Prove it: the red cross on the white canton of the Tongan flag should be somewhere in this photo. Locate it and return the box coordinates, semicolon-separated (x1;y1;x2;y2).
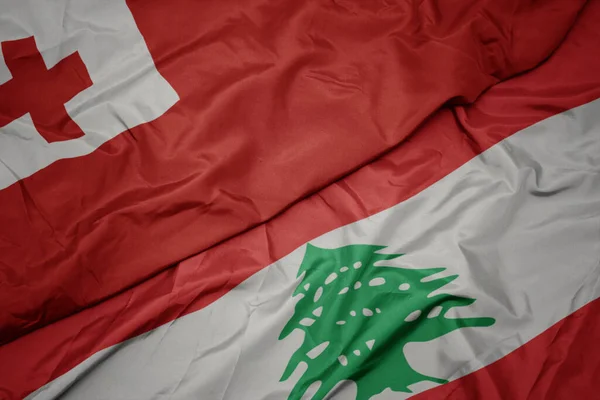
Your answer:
0;37;92;143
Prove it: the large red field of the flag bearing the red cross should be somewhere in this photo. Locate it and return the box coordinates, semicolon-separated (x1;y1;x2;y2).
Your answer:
0;0;584;343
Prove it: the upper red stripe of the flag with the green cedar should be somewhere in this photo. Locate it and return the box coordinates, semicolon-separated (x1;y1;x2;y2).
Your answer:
0;2;600;398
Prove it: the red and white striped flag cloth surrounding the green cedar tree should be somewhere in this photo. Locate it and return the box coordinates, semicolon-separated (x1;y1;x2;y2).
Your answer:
0;2;600;400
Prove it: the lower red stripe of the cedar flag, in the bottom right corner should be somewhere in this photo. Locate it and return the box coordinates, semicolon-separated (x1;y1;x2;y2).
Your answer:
414;300;600;400
